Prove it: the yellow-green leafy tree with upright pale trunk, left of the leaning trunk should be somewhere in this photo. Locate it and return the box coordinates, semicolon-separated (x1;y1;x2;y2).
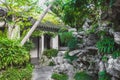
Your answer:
0;0;41;39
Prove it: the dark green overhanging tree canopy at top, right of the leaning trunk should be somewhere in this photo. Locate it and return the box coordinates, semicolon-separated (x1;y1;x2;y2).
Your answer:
52;0;109;28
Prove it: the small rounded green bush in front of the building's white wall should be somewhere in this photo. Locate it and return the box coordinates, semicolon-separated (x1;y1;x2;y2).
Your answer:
43;49;58;59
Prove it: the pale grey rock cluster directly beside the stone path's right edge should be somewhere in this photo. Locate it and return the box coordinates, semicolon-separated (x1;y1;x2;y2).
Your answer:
53;52;75;80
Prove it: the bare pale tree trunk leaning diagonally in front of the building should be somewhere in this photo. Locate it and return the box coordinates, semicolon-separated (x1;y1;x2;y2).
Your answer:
21;0;54;46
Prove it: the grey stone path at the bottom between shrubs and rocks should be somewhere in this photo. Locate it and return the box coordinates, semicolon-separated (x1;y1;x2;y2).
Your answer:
32;65;53;80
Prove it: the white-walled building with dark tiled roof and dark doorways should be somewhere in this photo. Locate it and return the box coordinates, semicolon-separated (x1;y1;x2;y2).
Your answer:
30;23;67;59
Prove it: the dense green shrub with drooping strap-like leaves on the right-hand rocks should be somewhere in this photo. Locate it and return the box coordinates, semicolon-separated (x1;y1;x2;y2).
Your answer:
96;37;120;58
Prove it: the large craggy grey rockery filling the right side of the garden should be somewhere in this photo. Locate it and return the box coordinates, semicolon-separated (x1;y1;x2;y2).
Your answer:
53;17;120;80
